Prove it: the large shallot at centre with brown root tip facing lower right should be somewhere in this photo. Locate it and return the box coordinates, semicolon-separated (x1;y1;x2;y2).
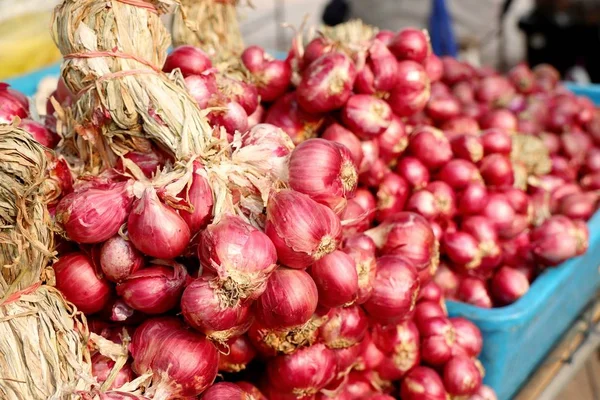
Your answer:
265;189;341;268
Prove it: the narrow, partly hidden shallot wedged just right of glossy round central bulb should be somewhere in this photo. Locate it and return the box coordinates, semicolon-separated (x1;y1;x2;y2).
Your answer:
342;235;376;304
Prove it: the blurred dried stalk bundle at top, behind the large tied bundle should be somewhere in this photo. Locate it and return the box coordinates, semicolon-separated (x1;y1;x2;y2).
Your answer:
172;0;244;60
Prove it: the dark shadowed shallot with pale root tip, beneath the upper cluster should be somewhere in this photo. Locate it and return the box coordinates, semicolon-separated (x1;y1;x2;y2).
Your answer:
265;92;323;145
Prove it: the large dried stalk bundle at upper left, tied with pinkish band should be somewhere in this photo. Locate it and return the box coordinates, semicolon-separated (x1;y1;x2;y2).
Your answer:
53;0;212;171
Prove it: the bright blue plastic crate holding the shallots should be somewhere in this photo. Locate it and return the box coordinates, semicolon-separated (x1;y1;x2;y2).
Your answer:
7;63;600;400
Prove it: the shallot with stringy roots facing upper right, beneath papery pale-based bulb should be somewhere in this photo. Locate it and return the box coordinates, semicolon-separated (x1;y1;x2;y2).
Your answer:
181;275;252;343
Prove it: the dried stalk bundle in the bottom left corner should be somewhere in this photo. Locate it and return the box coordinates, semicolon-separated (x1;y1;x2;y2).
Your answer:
0;285;93;400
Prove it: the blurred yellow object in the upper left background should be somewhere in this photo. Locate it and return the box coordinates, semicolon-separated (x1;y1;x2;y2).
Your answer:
0;11;61;80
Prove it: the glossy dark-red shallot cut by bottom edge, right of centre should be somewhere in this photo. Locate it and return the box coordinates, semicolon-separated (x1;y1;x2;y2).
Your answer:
400;366;448;400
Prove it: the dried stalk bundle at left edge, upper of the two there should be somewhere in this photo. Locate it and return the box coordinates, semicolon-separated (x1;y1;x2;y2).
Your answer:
0;125;52;296
